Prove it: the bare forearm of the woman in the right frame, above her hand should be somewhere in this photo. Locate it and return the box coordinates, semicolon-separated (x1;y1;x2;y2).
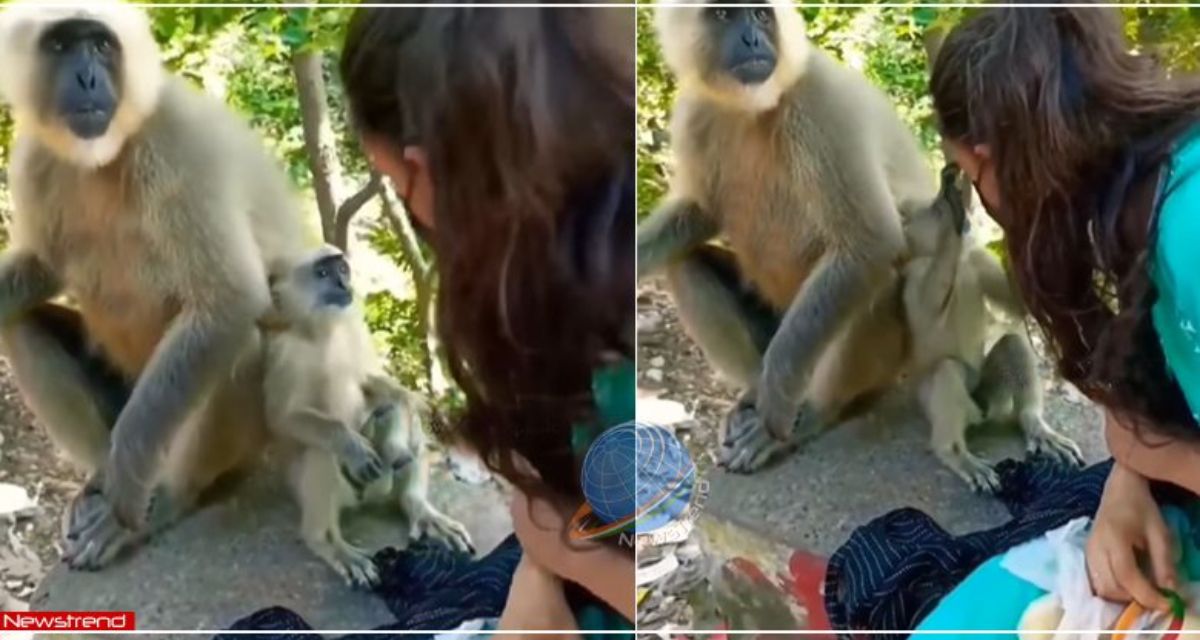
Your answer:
1104;412;1200;495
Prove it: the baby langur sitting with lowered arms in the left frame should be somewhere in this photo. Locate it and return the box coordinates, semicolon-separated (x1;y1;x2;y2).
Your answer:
262;246;473;587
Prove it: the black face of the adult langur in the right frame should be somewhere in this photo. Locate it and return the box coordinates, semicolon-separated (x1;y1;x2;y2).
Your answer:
704;5;779;85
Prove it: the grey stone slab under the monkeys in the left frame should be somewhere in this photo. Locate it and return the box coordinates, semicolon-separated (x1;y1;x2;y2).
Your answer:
30;449;512;630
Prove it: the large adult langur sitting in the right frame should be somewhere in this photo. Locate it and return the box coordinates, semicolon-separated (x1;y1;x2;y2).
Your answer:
637;0;936;472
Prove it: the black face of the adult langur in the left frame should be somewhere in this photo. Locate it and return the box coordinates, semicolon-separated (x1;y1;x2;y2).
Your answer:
38;19;121;139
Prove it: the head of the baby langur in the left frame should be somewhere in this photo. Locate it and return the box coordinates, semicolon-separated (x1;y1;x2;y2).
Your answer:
270;245;354;325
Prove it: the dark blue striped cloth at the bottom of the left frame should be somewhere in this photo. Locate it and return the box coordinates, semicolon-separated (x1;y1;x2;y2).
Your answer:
215;536;521;640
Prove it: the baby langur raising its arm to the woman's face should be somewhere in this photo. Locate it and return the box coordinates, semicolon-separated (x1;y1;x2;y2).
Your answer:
904;165;1082;491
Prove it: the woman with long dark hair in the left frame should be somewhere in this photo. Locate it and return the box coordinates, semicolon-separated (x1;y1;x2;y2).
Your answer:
341;7;635;629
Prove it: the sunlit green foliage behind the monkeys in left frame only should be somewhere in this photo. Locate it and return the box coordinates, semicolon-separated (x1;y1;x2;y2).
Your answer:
0;0;446;403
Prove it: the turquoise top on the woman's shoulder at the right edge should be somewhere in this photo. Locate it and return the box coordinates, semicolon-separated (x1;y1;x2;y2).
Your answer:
1151;126;1200;423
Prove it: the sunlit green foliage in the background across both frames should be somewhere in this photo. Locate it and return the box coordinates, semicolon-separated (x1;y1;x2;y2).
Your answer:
0;0;1200;402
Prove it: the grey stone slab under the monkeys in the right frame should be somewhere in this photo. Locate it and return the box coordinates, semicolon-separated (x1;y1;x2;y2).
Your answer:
704;389;1108;556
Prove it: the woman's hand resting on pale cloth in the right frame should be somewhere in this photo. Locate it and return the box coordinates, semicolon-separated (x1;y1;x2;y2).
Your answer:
1087;462;1177;611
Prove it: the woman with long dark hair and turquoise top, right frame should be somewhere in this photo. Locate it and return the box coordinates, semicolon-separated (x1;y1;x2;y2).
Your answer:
907;1;1200;628
